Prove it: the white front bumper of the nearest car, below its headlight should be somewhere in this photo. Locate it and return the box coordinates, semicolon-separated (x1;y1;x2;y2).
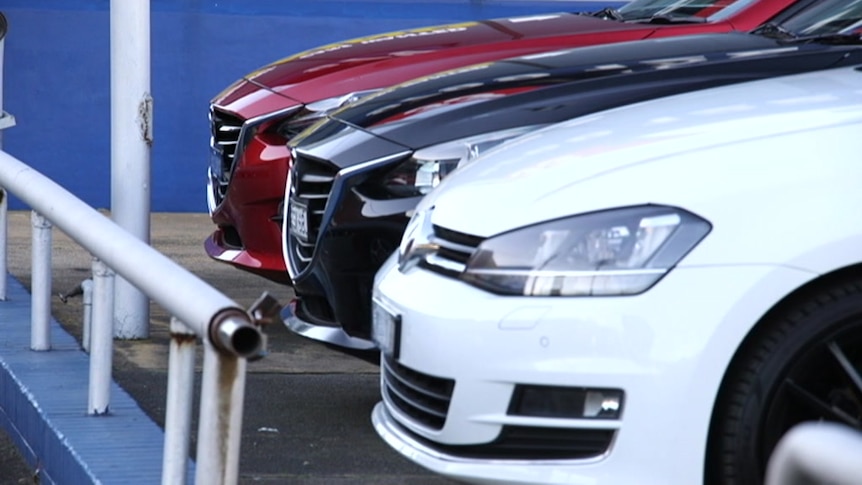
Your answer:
373;255;812;485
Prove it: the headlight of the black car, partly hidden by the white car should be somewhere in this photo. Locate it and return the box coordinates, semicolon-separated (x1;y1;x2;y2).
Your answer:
383;125;544;198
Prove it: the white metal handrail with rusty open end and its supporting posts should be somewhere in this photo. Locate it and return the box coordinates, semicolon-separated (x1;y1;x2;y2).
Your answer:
0;151;278;485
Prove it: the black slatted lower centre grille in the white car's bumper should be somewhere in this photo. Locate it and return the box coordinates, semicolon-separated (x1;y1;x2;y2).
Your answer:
381;357;455;430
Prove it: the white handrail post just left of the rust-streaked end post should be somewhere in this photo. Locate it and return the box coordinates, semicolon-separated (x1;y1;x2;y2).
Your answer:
162;317;197;485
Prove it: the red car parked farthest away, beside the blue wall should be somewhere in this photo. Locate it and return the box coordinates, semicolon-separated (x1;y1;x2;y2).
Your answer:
204;0;812;283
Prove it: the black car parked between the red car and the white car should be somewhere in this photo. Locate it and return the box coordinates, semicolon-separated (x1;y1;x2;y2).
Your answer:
283;1;862;349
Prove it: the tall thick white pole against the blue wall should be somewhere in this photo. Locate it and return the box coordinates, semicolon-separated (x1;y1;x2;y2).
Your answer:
111;0;153;339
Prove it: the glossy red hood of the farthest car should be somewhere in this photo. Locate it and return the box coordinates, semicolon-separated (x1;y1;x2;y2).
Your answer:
231;13;668;103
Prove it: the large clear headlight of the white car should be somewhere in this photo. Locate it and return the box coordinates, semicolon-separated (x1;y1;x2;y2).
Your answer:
461;205;712;296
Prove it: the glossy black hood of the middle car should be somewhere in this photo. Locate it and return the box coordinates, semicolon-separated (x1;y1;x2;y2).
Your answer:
294;33;862;167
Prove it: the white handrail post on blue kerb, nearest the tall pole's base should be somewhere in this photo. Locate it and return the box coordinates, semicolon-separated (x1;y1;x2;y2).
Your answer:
87;258;114;416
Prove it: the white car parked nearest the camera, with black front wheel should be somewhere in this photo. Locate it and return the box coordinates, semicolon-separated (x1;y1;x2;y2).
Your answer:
372;65;862;485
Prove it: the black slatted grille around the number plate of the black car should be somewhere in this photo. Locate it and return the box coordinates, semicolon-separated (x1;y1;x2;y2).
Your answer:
288;153;338;272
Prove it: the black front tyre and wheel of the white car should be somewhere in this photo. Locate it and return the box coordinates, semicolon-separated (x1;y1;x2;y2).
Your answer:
705;281;862;485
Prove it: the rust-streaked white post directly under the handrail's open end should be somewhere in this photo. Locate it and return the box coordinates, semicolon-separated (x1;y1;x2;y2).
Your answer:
195;339;247;485
